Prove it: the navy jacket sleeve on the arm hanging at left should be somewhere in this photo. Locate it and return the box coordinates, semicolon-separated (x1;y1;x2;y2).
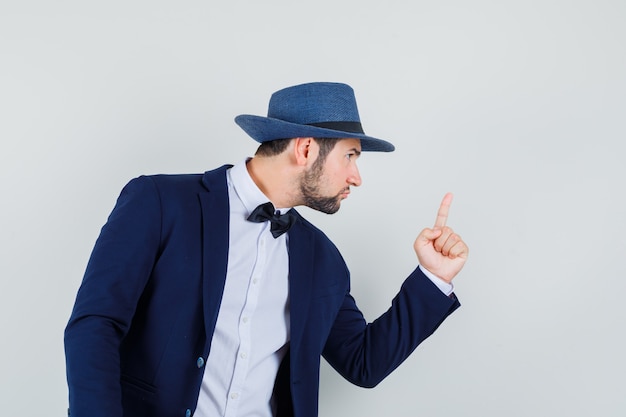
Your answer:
65;177;161;417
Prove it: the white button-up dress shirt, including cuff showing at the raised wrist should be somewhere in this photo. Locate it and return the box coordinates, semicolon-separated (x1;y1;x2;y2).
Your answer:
194;161;452;417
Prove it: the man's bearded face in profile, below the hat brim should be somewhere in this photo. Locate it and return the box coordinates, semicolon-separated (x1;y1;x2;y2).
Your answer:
300;139;361;214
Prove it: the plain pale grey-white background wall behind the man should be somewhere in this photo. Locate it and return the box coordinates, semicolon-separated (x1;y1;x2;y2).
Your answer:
0;0;626;417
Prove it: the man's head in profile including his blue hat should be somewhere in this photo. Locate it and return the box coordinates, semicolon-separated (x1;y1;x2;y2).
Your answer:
235;83;388;213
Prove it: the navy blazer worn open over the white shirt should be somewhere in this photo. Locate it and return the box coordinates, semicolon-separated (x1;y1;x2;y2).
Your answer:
65;166;459;417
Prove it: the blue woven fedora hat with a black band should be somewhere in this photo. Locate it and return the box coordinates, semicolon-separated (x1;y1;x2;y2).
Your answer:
235;82;395;152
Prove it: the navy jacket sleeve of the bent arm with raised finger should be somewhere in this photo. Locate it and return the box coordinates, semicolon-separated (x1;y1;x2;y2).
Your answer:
323;268;460;388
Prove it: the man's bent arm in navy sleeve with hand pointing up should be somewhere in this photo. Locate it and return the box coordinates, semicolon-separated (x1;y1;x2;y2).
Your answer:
324;194;468;387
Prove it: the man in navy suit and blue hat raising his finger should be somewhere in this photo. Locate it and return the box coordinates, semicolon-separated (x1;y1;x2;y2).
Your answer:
65;83;468;417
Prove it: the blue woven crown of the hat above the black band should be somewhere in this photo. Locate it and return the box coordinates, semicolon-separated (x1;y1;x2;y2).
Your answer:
267;82;360;125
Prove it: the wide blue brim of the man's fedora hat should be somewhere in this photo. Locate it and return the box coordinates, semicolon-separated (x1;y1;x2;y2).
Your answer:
235;114;396;152
